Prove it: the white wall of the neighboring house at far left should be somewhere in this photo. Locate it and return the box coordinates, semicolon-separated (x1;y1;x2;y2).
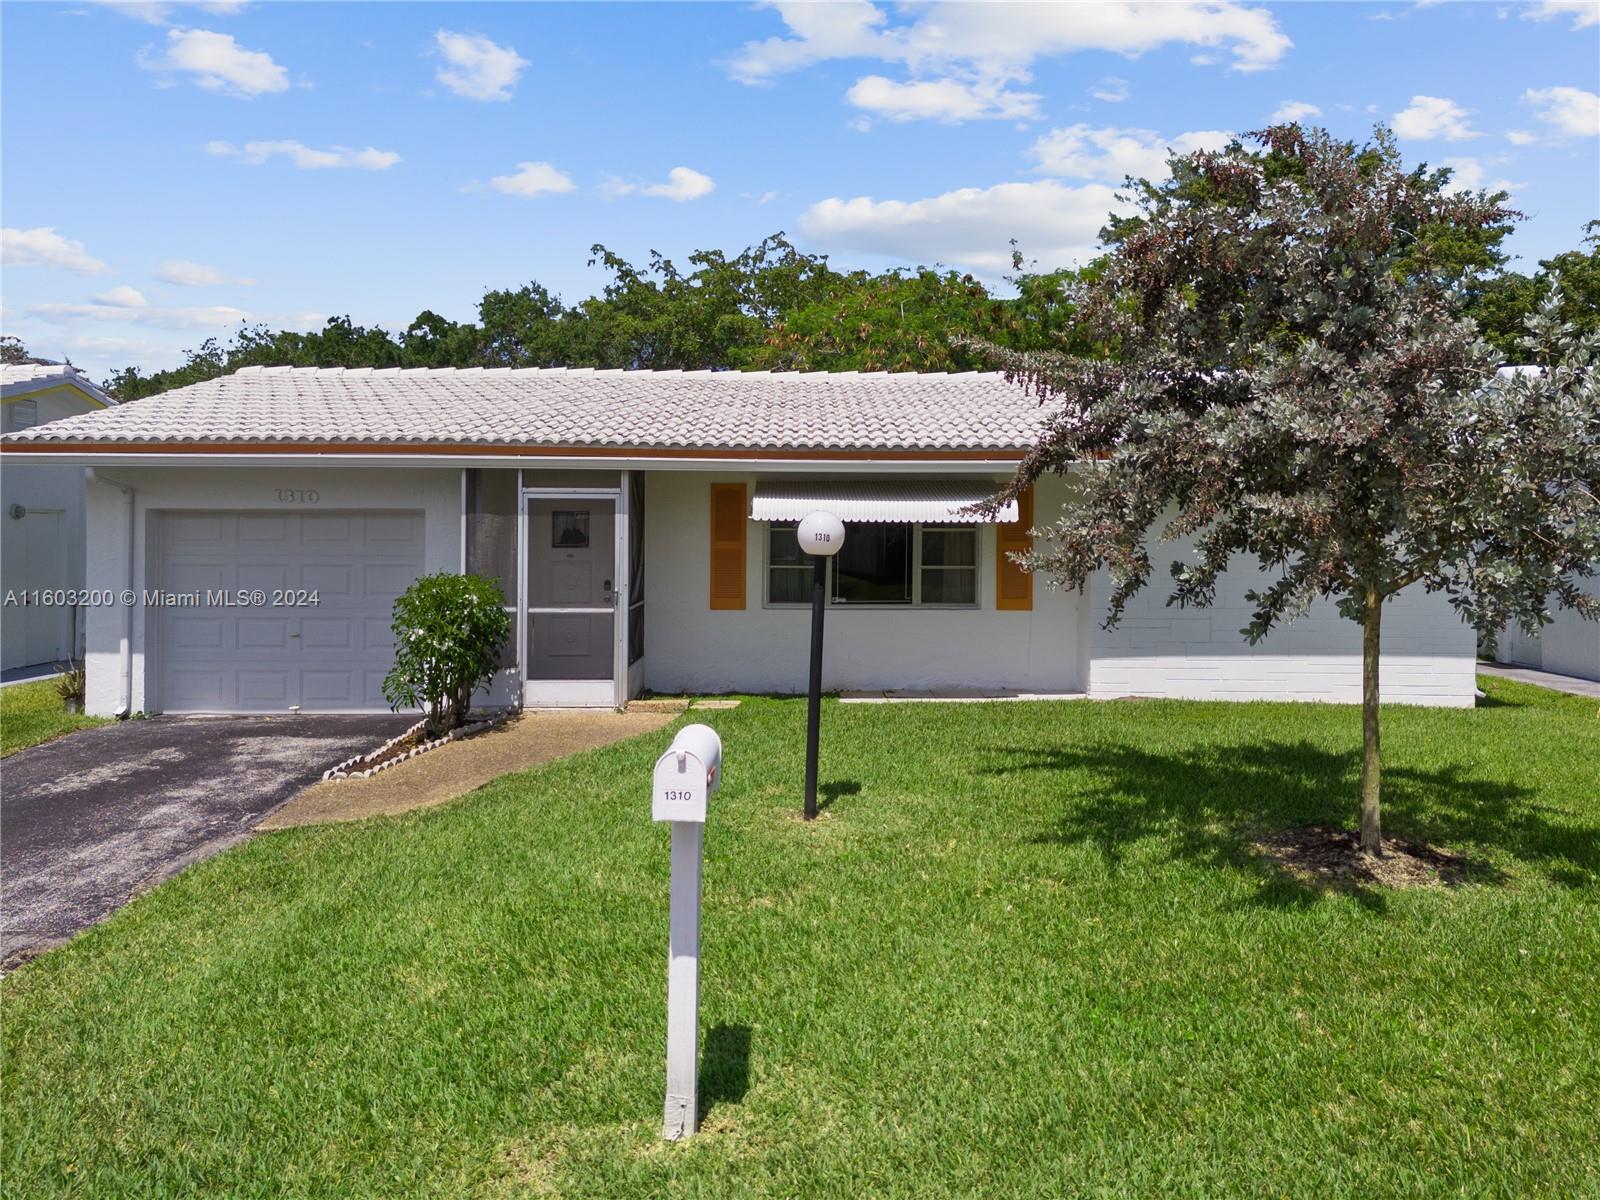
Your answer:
0;387;96;669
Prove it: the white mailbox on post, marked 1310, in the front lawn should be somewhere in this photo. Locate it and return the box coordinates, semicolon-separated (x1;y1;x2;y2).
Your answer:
650;725;722;1141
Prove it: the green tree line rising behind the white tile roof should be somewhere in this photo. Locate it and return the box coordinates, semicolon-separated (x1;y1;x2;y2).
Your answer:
43;137;1600;400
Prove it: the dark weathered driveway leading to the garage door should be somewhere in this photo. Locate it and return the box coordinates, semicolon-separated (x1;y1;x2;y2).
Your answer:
0;714;416;963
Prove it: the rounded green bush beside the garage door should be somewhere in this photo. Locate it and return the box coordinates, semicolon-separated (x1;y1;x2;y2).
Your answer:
384;571;510;738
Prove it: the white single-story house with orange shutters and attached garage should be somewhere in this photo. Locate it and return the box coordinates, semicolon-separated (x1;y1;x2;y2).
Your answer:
5;368;1475;714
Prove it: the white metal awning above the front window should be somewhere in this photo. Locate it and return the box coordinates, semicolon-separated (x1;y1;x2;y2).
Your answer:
750;478;1018;525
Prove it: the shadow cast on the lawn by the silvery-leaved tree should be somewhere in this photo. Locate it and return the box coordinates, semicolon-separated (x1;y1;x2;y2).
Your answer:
981;741;1600;909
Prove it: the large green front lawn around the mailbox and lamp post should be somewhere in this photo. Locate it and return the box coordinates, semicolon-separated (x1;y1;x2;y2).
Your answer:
3;680;1600;1197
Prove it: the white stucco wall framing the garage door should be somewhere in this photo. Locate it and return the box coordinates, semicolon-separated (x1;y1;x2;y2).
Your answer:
86;467;461;715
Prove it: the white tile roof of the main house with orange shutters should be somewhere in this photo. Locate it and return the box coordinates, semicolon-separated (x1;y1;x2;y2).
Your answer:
6;366;1043;451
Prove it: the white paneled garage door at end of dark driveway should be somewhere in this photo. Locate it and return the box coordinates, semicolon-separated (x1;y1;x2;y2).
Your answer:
152;512;422;712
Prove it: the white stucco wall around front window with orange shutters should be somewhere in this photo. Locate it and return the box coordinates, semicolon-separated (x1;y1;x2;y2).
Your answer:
645;470;1083;693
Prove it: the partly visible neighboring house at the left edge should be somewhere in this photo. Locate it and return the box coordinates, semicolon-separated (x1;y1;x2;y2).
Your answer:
0;363;117;670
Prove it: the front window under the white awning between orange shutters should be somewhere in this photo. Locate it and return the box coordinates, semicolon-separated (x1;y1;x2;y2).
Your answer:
766;522;978;608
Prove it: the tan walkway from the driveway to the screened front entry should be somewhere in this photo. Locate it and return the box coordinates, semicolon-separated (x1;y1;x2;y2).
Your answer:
256;706;682;829
